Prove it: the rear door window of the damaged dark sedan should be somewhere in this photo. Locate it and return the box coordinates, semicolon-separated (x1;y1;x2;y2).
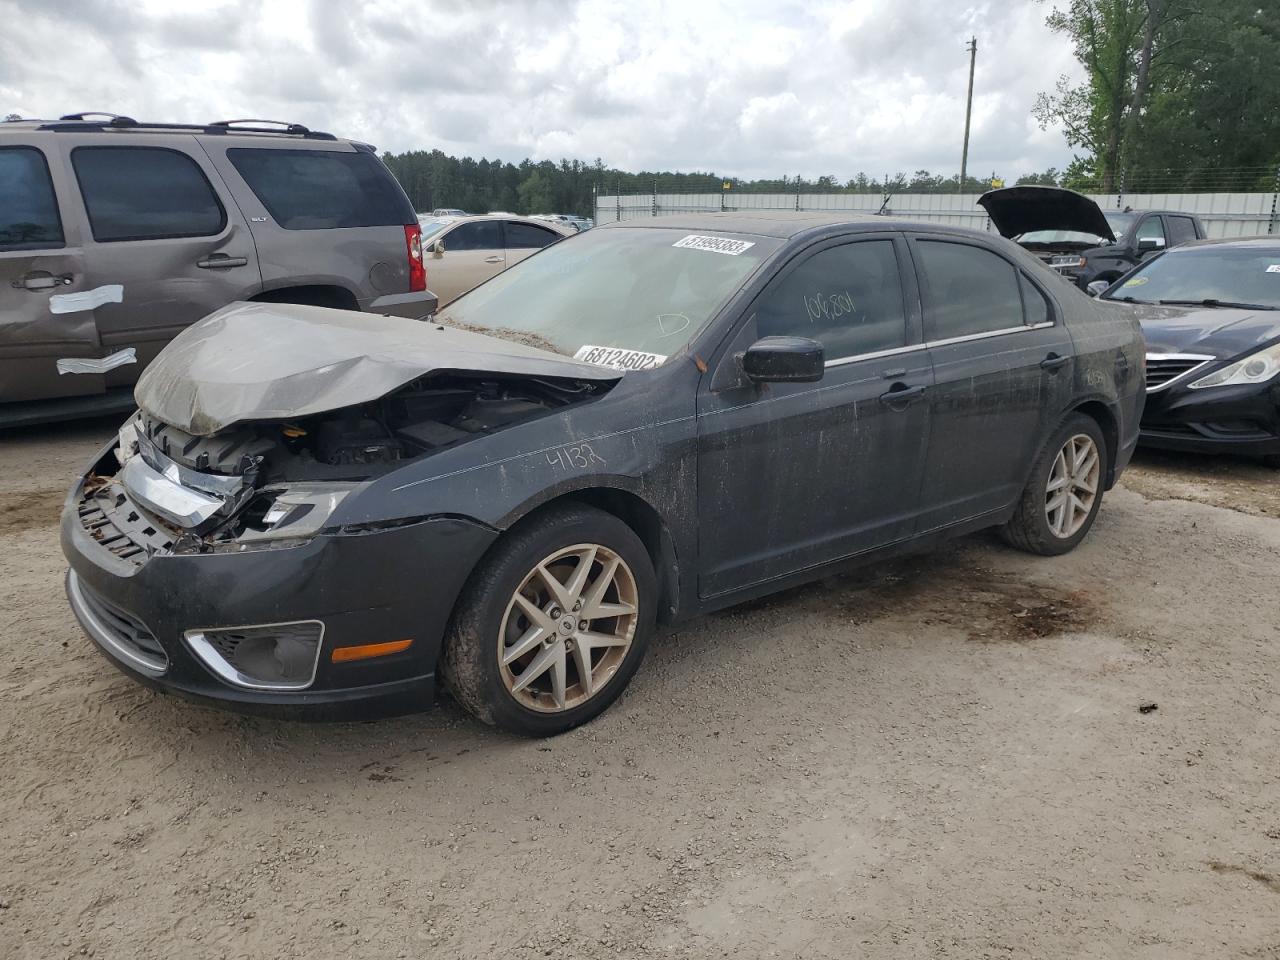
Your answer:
915;241;1023;340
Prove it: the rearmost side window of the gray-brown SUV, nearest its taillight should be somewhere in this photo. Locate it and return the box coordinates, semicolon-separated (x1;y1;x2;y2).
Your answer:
227;147;417;230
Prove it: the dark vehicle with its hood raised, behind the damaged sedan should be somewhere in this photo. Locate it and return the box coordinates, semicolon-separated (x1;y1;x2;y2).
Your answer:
978;186;1206;289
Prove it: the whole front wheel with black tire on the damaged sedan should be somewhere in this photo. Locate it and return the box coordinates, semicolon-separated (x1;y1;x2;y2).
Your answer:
442;506;658;736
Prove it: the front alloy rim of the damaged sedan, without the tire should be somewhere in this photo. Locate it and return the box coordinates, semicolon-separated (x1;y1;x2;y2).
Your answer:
498;544;639;713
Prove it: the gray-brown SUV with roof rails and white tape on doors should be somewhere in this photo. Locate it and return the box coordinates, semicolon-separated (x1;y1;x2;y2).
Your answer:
0;114;435;425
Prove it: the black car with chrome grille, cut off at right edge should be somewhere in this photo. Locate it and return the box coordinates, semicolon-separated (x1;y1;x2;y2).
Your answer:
1100;237;1280;466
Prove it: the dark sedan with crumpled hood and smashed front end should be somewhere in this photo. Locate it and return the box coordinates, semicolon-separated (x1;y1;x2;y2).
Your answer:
61;214;1144;735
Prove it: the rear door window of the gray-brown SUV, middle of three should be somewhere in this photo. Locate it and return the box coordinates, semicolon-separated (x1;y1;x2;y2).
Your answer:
72;147;227;243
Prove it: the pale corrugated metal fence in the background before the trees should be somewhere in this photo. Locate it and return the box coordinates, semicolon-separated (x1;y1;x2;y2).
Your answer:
595;191;1280;237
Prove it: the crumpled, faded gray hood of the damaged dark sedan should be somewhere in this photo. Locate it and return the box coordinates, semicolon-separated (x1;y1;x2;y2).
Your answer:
133;303;622;436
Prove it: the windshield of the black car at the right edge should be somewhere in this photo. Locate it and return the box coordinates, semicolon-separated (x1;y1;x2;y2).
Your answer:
1103;243;1280;310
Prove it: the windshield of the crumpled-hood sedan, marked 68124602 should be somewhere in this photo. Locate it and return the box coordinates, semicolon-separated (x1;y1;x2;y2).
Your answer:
436;227;782;366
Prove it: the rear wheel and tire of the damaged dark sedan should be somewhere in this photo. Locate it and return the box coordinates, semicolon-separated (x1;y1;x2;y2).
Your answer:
1000;413;1110;557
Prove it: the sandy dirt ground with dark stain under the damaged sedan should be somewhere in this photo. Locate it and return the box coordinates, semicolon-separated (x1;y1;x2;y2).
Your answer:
0;422;1280;960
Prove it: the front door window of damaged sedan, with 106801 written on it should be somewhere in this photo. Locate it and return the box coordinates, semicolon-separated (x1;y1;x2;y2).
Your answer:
755;239;906;360
